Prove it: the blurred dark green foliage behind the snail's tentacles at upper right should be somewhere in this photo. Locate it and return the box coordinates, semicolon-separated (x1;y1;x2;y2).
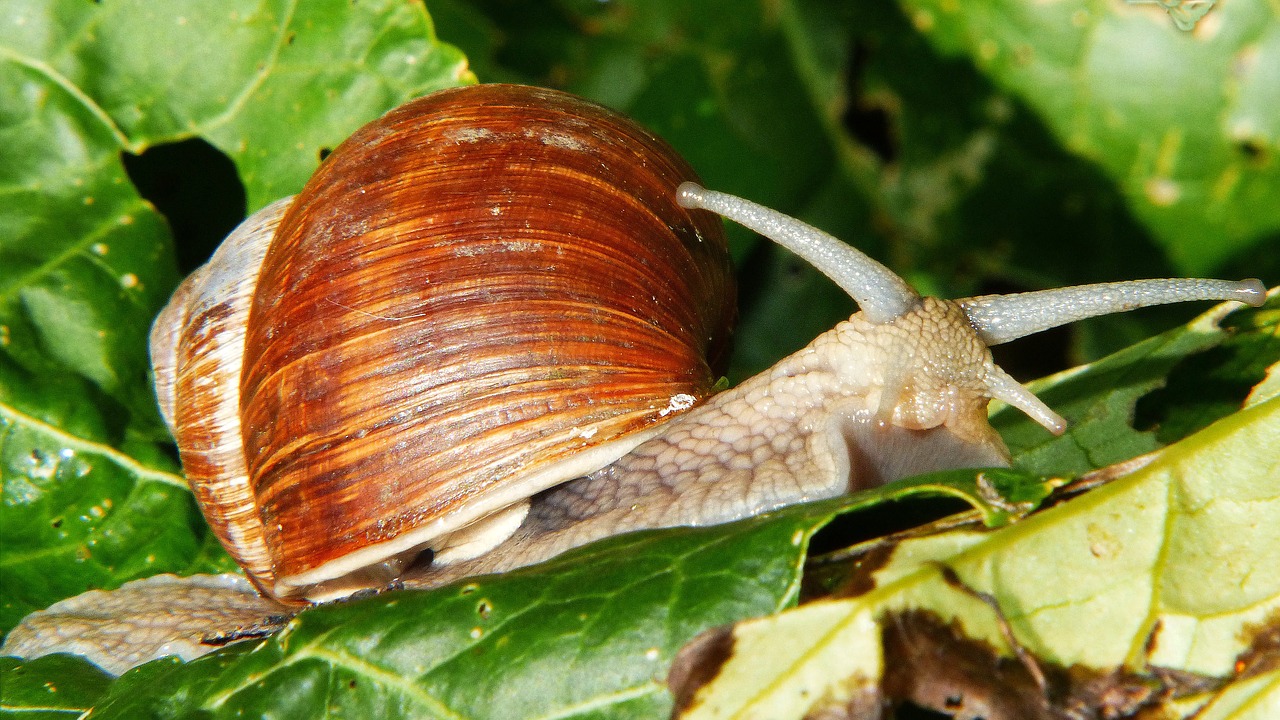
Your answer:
404;0;1280;380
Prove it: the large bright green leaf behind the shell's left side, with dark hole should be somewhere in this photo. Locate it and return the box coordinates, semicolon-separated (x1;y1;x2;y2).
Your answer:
0;0;467;630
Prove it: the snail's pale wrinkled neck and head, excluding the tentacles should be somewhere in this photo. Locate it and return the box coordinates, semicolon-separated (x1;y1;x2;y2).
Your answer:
419;293;1009;585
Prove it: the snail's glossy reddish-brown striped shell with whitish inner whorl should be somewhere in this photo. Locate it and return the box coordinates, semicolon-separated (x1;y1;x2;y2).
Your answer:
152;85;733;601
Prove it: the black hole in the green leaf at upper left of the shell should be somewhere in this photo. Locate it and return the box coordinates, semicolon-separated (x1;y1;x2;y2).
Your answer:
120;138;246;273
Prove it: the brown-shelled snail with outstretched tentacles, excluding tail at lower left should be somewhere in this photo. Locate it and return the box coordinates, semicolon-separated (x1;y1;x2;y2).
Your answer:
0;85;1265;671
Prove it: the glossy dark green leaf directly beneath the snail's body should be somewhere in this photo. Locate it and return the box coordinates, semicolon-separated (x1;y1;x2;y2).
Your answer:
20;461;1048;717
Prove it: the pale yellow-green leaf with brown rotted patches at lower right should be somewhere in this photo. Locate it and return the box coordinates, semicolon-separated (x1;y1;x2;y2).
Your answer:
687;379;1280;717
